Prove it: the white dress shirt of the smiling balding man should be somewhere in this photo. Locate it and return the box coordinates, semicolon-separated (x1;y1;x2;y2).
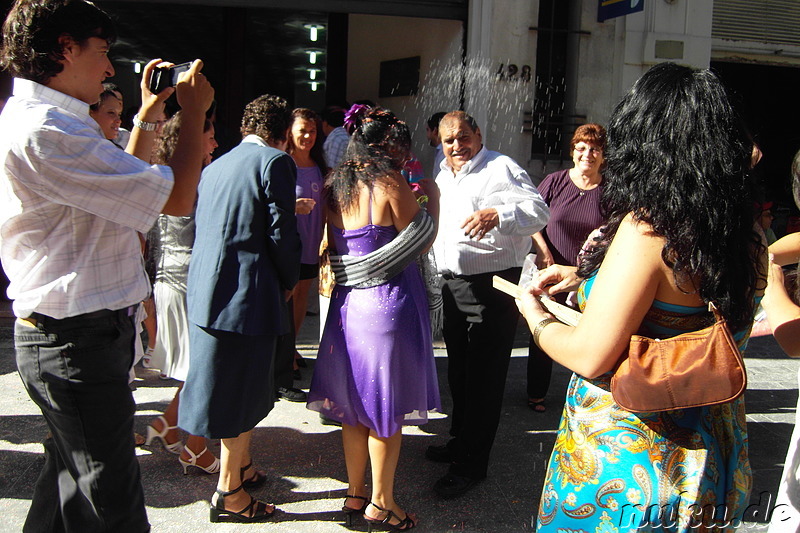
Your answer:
433;147;550;275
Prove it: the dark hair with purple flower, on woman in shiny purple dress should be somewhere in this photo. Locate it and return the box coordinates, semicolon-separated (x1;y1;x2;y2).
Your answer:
325;107;411;213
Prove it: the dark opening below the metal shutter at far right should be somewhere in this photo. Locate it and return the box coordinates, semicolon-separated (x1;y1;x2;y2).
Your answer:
711;61;800;231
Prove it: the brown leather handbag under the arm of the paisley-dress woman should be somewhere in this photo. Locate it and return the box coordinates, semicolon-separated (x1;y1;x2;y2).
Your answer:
611;303;747;413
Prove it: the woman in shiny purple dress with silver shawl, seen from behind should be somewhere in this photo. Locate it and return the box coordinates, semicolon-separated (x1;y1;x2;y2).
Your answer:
308;108;440;530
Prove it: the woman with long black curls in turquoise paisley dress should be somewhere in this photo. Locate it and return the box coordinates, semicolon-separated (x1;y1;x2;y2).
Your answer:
520;63;766;533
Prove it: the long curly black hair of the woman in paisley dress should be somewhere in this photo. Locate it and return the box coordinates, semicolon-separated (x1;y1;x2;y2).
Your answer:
580;63;766;331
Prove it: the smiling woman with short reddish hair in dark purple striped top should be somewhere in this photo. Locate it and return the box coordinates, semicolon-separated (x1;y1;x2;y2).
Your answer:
528;124;606;413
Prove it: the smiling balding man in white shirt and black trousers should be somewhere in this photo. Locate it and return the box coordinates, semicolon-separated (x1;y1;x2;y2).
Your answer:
425;111;549;497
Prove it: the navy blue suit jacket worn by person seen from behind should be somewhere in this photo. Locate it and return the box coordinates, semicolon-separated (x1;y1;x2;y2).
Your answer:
187;142;301;335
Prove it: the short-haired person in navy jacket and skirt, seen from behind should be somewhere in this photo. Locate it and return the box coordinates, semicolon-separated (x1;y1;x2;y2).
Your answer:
178;95;301;522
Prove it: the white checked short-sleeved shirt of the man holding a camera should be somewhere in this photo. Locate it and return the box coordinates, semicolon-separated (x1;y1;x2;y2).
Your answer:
0;79;173;318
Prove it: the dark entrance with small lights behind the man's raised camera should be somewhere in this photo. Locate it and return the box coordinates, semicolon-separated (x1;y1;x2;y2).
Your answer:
97;2;338;154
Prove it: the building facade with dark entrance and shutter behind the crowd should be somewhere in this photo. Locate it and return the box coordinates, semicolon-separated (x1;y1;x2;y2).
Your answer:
20;0;800;188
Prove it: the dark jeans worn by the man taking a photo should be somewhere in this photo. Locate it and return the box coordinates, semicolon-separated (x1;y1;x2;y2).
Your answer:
14;309;150;533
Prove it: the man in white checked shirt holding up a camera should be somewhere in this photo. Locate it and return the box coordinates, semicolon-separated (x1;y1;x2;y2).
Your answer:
0;0;214;532
